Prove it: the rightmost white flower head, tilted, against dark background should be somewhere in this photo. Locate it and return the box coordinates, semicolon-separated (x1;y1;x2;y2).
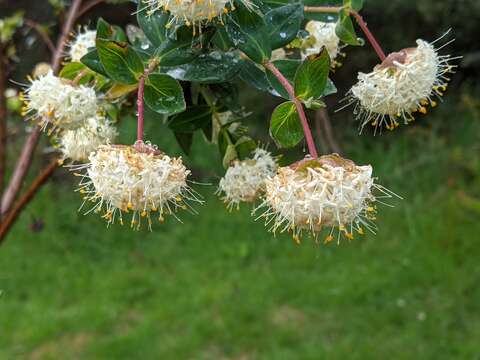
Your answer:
347;33;455;130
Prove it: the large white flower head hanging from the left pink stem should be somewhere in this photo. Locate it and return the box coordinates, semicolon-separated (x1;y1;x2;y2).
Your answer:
77;142;199;229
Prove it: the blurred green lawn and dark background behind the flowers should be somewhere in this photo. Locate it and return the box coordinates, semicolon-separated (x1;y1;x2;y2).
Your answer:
0;1;480;360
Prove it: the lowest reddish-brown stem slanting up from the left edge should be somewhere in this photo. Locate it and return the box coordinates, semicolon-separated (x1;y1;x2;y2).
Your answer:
0;159;58;245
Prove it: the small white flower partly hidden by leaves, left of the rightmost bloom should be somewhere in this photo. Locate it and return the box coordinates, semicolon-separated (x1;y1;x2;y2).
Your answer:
302;20;343;67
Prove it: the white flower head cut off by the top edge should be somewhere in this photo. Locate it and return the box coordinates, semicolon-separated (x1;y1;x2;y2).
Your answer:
144;0;251;31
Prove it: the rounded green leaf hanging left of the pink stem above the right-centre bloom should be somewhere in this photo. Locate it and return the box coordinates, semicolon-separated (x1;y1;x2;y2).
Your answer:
270;101;303;148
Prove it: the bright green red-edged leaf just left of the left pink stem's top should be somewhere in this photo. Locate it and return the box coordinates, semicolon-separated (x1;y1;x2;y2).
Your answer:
96;39;143;84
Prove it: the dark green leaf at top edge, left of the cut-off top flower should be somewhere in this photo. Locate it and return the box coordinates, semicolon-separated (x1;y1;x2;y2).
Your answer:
137;0;170;47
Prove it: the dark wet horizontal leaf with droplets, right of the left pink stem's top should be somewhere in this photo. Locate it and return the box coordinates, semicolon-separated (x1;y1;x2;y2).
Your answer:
161;51;239;84
